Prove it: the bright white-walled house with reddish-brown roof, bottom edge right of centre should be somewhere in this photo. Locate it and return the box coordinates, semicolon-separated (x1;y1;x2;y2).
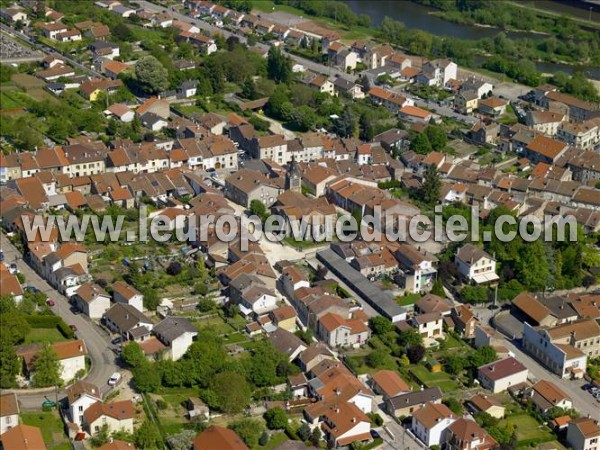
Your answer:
410;402;457;448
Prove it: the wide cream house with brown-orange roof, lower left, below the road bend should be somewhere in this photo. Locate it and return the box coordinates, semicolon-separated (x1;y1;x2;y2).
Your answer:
83;400;135;435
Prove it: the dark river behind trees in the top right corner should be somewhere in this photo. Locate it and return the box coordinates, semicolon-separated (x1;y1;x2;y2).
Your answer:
346;0;600;80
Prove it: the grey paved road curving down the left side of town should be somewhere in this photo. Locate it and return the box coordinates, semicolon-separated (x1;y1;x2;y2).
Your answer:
0;233;119;410
